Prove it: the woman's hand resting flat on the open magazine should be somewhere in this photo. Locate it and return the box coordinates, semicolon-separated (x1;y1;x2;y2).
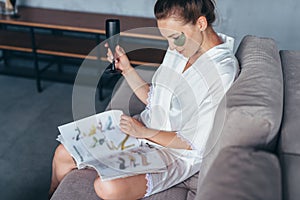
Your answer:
120;115;147;138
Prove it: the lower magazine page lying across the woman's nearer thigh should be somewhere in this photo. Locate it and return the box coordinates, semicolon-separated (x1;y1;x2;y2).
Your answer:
87;146;167;180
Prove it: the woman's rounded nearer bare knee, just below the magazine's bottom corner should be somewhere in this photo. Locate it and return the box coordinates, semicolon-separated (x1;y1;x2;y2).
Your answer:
94;177;126;199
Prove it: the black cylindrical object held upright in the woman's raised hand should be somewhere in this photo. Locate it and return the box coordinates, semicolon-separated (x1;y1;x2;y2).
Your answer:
105;19;120;72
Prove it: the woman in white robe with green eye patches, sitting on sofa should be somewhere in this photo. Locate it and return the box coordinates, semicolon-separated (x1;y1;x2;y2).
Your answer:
50;0;238;199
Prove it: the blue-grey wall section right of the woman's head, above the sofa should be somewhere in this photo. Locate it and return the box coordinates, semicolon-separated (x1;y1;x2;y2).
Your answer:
216;0;300;50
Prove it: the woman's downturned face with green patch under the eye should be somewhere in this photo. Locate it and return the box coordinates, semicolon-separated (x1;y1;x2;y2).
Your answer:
157;17;203;58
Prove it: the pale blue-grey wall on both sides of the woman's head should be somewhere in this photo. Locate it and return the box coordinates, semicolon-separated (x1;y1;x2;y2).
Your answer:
19;0;300;50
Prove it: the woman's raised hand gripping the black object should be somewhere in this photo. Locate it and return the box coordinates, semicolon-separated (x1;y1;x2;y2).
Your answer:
104;43;133;74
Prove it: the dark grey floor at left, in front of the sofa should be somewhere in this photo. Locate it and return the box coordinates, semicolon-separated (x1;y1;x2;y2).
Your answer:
0;75;109;200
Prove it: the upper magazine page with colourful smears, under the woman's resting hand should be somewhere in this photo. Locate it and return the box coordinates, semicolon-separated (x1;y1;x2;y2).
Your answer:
58;110;140;168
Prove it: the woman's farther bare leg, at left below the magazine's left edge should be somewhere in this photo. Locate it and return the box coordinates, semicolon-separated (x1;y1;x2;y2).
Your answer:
49;144;76;195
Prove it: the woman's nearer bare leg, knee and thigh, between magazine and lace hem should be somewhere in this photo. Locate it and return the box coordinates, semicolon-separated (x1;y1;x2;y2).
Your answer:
94;174;147;200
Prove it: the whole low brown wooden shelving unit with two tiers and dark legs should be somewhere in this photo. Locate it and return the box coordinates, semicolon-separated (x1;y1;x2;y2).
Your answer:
0;7;166;91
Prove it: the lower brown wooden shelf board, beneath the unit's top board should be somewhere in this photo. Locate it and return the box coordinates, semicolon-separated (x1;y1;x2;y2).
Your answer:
0;30;165;66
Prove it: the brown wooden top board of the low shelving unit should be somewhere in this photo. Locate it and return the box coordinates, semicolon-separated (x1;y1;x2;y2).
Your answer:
0;6;163;40
